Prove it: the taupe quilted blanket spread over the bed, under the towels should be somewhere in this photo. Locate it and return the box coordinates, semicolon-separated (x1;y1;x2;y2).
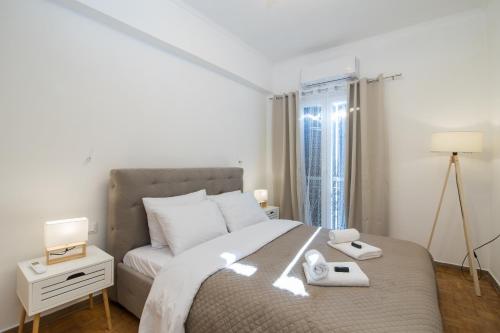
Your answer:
185;226;442;333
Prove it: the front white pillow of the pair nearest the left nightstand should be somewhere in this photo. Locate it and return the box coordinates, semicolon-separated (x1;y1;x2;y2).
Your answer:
153;200;227;255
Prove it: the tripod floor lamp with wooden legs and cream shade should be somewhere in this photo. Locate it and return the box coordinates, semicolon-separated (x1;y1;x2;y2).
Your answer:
427;132;483;296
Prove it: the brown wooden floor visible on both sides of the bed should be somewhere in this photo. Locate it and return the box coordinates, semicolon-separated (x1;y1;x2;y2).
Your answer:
9;265;500;333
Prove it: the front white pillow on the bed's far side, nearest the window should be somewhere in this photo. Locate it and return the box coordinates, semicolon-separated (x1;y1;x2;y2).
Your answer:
210;192;269;232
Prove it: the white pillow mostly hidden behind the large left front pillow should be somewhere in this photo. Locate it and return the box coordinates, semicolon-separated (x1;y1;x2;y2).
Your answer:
142;190;207;249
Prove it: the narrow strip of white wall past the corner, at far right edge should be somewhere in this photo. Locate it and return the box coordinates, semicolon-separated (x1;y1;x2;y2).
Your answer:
487;0;500;283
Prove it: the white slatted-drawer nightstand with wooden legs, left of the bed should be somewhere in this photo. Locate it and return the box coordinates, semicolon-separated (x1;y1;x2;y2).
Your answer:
17;246;114;333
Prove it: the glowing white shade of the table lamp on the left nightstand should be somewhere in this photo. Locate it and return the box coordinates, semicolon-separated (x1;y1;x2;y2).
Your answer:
45;217;89;248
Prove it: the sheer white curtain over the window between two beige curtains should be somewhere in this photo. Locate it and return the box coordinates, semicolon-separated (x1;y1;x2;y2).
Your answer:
299;82;348;229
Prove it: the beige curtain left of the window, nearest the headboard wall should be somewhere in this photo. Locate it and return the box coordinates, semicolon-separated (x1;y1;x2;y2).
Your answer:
272;92;302;221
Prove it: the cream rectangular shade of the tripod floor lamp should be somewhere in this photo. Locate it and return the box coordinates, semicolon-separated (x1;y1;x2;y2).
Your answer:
431;132;483;153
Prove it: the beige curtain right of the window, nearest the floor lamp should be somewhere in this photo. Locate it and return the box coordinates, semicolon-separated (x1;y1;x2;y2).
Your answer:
345;76;389;235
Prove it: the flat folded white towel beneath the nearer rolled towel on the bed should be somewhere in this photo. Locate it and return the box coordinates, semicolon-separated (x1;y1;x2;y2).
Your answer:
302;262;370;287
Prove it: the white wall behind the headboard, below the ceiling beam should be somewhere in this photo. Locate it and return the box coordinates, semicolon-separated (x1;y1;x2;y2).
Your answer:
0;0;266;331
